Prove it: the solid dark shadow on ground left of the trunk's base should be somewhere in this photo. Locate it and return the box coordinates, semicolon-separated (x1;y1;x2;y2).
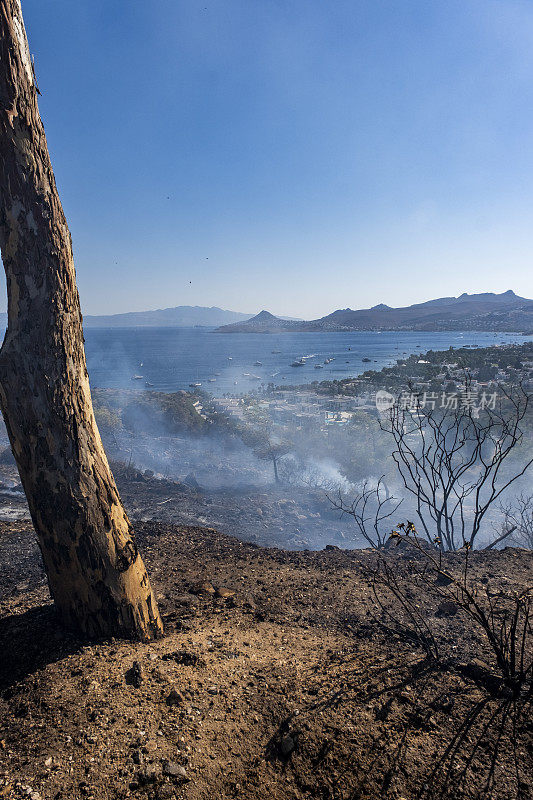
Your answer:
0;604;85;693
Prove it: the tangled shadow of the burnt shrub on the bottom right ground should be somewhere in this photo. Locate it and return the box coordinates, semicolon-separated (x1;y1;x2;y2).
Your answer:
265;653;533;800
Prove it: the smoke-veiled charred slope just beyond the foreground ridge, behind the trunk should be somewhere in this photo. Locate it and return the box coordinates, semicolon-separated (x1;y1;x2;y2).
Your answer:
0;462;361;550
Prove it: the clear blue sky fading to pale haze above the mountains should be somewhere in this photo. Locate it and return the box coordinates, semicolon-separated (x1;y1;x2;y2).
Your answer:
7;0;533;318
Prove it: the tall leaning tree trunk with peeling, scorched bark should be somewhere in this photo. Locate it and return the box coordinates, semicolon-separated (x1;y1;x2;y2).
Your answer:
0;0;162;639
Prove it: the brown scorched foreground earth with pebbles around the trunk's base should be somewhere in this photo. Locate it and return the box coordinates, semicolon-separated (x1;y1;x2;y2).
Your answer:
0;520;533;800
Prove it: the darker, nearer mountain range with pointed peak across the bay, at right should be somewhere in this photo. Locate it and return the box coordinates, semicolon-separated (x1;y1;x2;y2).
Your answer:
217;289;533;333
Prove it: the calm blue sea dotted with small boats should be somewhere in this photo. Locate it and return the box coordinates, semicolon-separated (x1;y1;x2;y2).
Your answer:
85;328;533;397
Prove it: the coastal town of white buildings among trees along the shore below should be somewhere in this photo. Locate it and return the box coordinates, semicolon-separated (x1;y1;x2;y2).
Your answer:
212;342;533;433
